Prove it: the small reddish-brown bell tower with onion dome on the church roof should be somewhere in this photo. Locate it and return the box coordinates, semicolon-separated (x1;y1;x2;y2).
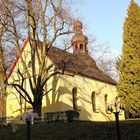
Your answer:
71;20;88;54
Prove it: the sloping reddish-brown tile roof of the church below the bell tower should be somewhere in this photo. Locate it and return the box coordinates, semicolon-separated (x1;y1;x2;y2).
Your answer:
48;47;117;85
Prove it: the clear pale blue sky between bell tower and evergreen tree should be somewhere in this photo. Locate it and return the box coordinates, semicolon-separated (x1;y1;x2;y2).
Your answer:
77;0;140;57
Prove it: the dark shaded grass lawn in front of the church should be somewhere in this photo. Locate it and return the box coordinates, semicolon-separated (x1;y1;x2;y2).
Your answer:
0;120;140;140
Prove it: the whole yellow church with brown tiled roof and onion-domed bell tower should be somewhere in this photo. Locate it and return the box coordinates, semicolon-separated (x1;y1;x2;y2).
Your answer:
6;20;124;121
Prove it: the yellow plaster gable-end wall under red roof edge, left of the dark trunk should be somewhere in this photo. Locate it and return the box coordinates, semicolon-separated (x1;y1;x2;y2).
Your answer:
6;42;31;117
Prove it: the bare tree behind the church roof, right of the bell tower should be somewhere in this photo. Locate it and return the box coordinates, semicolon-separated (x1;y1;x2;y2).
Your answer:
89;35;118;81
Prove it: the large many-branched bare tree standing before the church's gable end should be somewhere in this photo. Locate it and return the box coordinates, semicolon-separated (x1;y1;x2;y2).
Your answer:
0;0;75;115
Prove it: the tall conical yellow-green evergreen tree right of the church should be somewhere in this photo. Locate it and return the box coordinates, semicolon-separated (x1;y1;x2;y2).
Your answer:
118;0;140;117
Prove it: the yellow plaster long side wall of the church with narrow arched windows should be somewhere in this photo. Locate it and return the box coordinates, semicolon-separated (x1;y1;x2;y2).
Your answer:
43;75;124;121
